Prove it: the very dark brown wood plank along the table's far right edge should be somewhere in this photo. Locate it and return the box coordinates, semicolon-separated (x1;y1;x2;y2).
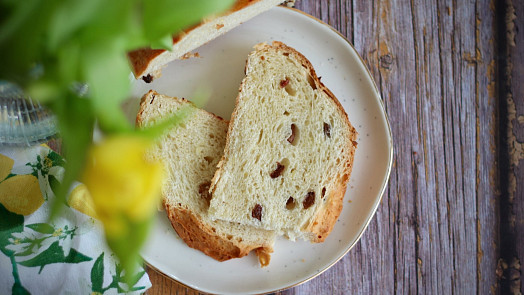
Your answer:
498;0;524;294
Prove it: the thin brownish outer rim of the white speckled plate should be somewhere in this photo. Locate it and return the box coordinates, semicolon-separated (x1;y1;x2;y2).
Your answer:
141;5;394;294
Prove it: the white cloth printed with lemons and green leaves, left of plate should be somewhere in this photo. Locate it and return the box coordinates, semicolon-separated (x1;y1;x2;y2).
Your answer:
0;146;151;294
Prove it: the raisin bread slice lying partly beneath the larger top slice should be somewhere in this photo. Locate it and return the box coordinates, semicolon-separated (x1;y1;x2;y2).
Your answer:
136;91;275;266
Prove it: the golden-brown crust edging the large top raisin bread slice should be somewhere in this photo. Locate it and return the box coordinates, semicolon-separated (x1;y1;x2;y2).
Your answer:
212;41;358;243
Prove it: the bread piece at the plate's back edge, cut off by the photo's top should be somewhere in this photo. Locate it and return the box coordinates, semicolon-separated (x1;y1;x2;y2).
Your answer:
128;0;285;83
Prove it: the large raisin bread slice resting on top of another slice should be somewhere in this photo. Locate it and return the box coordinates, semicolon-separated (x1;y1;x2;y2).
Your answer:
209;42;357;242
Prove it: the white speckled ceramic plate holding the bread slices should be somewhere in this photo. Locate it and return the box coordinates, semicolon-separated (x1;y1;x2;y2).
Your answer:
131;7;392;294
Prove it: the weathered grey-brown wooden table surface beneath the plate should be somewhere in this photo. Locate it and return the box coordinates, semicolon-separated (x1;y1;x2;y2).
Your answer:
147;0;524;295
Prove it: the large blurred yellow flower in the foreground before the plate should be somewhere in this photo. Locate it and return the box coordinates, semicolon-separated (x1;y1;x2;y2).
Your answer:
83;135;164;237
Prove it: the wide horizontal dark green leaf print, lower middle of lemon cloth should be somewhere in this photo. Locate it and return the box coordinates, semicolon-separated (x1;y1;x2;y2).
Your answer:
18;241;93;273
